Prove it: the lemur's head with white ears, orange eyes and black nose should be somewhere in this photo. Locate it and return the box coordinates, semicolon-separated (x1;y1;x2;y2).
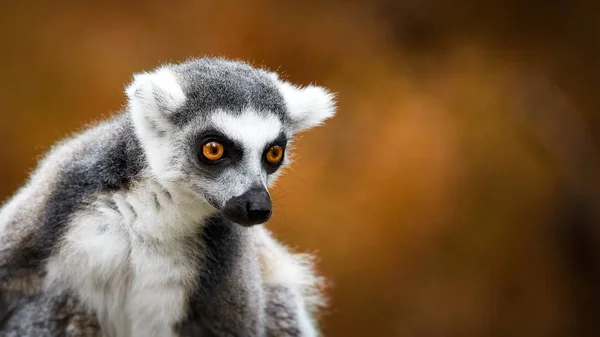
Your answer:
126;58;335;226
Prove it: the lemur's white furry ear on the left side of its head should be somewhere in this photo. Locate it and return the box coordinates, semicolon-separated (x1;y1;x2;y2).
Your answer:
125;67;185;119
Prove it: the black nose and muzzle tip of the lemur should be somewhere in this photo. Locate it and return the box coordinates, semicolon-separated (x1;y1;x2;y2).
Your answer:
221;187;271;226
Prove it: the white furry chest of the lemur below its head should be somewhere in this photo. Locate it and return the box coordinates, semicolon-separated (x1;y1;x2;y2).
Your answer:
48;182;210;337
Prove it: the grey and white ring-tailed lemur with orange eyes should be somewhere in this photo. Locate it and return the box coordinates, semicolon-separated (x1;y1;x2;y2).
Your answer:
0;58;335;337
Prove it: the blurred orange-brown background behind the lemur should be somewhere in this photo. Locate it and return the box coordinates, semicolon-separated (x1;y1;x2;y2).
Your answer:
0;0;600;337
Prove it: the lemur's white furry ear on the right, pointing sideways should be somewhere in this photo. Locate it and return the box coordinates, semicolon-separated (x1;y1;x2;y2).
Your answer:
280;81;335;132
